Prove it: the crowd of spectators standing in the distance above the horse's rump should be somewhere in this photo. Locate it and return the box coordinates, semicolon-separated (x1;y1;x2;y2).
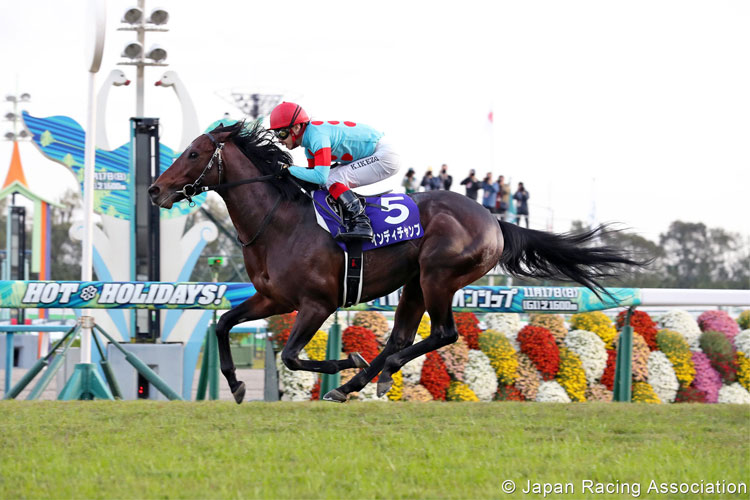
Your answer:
401;164;529;227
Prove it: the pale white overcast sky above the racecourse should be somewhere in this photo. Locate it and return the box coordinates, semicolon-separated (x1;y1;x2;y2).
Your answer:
0;0;750;241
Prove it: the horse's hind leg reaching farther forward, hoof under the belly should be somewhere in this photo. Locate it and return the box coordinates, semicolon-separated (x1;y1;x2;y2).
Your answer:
323;276;424;403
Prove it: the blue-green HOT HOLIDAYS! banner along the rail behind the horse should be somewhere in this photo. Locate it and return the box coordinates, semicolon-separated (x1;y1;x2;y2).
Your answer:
0;281;641;314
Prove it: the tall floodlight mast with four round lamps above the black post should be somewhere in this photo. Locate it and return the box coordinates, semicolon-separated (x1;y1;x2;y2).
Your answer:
117;0;169;117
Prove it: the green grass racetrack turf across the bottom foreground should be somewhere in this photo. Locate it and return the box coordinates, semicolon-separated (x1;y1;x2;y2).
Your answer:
0;401;750;499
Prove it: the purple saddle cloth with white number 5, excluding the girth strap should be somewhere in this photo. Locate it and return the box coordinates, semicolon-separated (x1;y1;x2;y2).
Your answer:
313;190;424;252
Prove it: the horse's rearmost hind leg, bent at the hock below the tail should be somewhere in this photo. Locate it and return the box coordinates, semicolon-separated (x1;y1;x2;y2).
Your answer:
378;274;458;397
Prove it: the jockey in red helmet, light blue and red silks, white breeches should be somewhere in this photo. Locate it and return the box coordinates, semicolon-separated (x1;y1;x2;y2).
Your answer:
271;102;401;240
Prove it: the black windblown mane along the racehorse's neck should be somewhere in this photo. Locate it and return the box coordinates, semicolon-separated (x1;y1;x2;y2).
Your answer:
212;121;317;202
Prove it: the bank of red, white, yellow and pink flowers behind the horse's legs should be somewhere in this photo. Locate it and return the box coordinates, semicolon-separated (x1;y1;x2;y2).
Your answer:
273;304;750;404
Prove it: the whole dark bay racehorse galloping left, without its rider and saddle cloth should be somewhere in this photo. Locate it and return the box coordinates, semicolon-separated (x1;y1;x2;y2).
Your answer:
148;124;642;403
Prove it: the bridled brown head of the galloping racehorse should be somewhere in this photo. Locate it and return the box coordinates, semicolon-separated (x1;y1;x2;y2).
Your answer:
148;132;229;209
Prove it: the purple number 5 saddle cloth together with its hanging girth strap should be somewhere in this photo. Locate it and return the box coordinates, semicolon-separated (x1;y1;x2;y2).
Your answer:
313;190;424;307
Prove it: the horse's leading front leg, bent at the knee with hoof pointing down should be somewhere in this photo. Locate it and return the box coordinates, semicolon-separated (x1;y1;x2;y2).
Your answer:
216;292;292;404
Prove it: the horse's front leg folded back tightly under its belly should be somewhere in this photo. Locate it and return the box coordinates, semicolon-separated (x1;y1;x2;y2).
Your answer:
281;304;369;373
